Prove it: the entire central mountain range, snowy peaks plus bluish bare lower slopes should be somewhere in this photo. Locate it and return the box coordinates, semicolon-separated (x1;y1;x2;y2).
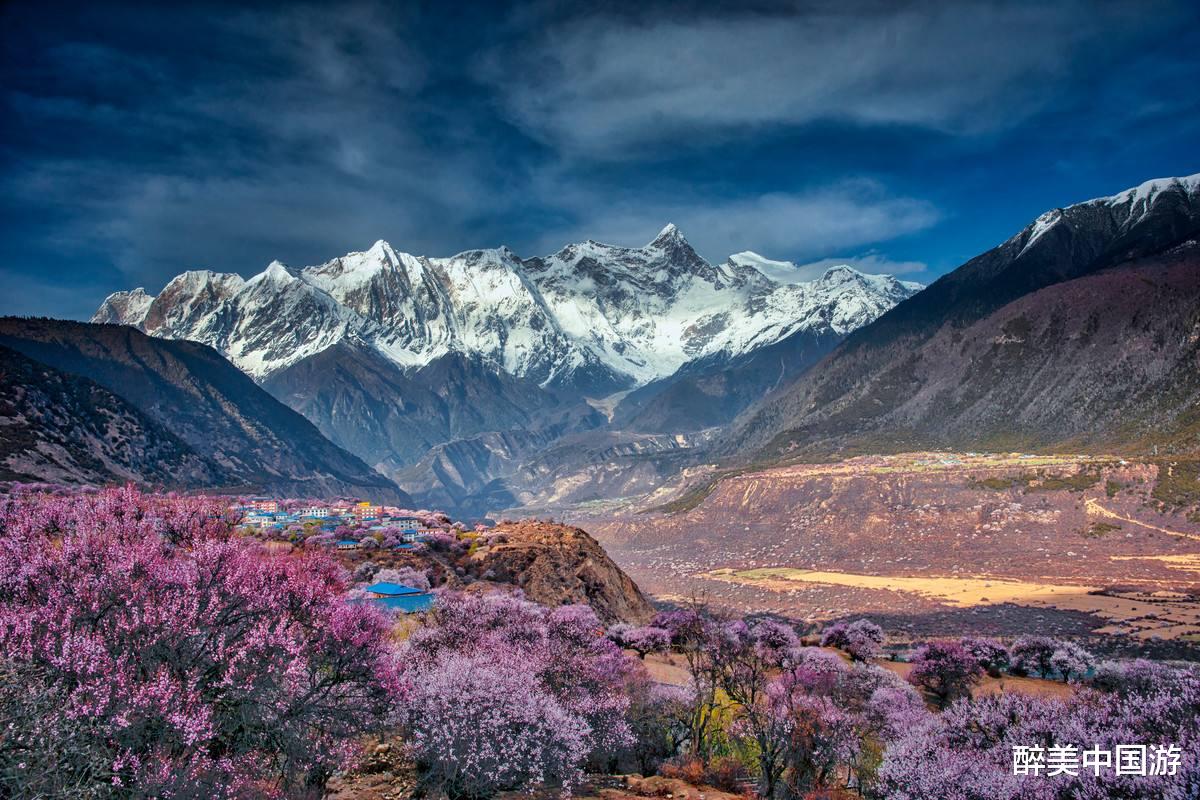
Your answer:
94;225;920;512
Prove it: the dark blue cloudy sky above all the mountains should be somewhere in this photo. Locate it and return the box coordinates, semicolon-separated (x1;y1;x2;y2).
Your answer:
0;0;1200;318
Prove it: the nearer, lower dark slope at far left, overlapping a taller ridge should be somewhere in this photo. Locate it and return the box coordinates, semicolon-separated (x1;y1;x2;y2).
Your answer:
0;347;226;488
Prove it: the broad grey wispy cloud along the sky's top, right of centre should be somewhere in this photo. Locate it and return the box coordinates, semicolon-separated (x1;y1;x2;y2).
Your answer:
478;0;1140;158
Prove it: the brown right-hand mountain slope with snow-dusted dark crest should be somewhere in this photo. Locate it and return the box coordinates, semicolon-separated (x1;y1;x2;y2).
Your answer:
719;175;1200;461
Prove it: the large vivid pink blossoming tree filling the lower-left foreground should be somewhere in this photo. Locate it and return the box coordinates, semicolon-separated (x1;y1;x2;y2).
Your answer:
0;488;397;798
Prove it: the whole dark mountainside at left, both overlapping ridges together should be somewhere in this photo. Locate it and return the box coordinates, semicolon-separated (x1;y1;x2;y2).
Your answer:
0;318;409;501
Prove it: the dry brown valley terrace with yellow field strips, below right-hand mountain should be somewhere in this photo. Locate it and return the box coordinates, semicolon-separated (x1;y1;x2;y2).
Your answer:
585;452;1200;640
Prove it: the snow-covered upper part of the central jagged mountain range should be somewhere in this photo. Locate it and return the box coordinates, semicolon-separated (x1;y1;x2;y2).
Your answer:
92;225;919;393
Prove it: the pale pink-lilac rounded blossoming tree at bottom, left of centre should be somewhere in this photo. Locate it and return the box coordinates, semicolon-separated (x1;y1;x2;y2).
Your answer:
397;593;634;798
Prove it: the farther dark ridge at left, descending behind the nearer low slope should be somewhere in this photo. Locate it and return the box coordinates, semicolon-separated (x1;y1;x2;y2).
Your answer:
0;318;404;500
